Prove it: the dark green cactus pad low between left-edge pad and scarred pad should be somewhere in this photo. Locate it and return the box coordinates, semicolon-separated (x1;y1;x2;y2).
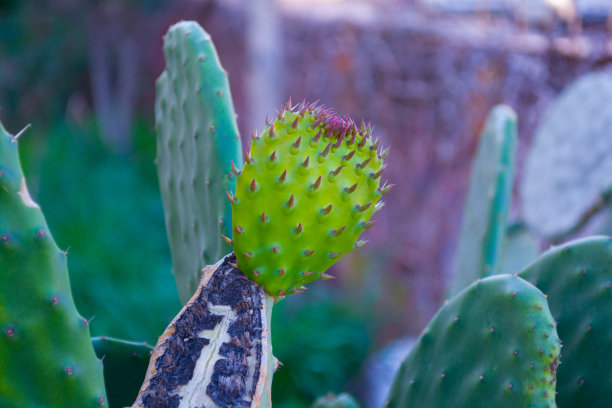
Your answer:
91;336;153;408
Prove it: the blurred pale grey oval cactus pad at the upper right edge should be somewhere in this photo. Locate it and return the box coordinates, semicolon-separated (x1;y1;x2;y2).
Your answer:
521;73;612;239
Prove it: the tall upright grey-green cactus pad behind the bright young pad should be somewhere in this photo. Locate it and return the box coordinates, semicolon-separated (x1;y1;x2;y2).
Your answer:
155;21;242;302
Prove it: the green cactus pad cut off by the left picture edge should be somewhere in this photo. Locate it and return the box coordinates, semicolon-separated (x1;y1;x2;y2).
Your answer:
0;124;108;408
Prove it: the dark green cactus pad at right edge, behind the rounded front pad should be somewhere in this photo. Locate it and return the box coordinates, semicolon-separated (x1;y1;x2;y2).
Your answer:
520;237;612;408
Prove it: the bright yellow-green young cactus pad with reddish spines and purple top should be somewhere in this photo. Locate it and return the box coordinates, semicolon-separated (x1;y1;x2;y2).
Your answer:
228;102;390;296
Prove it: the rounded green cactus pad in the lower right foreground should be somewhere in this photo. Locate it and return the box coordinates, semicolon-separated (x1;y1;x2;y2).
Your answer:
387;275;561;408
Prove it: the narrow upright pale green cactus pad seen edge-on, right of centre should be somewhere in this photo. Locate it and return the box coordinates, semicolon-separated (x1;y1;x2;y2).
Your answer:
449;105;517;296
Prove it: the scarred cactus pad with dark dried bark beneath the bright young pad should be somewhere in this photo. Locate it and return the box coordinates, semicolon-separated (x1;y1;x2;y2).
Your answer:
133;255;275;408
